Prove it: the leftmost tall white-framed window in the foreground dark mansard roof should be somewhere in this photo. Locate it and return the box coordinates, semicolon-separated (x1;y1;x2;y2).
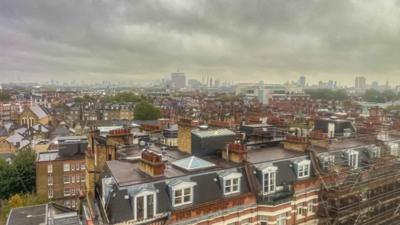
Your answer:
135;192;156;221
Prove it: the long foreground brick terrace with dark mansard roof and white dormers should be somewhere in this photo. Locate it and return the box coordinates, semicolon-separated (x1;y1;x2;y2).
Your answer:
83;118;400;225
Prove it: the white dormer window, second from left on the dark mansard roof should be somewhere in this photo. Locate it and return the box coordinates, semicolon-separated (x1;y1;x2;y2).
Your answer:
170;181;196;207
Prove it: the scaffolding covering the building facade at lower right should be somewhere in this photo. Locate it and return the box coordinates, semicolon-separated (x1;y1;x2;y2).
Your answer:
309;137;400;225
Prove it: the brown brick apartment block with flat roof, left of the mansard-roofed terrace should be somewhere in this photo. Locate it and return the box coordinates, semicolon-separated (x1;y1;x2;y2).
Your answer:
36;137;88;208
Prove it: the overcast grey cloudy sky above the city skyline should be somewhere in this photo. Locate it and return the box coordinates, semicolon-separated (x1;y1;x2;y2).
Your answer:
0;0;400;85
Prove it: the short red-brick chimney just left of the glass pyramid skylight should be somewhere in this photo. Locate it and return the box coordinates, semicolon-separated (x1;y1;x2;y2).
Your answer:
139;150;165;177
